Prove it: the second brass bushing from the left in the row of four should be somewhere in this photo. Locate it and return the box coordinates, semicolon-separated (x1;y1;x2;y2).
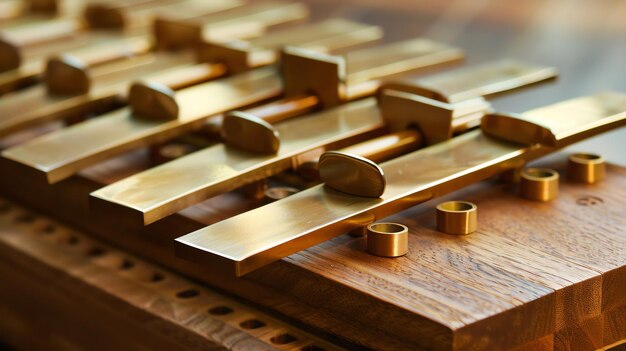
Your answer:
437;201;478;235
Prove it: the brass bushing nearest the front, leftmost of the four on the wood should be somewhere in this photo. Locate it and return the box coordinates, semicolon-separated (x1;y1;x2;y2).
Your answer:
367;223;409;257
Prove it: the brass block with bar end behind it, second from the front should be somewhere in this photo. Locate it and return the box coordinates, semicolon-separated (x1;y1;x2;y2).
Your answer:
380;60;556;145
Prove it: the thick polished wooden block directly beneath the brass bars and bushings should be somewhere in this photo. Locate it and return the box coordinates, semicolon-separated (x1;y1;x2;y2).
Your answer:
2;153;626;350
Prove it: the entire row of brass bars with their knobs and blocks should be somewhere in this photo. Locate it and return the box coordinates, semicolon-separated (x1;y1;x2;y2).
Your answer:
0;0;626;275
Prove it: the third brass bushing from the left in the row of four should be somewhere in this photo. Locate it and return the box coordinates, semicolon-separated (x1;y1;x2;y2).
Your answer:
520;168;559;201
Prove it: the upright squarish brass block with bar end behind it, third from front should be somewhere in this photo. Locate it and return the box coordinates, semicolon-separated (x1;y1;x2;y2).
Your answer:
281;38;463;107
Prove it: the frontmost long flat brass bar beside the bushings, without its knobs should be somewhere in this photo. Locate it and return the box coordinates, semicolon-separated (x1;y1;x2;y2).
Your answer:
173;93;626;276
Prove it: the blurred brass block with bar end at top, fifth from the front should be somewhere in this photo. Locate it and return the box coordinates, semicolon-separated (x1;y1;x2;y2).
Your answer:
154;1;309;50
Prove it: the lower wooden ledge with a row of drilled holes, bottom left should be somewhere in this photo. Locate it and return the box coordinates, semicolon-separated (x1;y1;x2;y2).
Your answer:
0;200;340;350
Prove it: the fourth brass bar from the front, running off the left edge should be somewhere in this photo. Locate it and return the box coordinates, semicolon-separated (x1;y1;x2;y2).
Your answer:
0;54;219;136
